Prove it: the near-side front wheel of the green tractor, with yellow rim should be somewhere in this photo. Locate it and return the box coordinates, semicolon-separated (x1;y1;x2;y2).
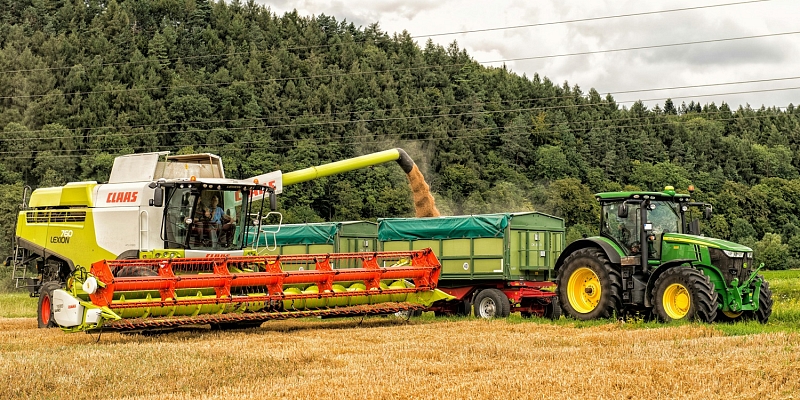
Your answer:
652;267;718;322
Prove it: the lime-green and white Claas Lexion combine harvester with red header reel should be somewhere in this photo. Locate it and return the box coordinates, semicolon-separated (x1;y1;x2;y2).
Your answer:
11;149;448;332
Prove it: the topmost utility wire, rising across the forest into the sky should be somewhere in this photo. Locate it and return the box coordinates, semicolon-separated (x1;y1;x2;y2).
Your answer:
0;0;771;74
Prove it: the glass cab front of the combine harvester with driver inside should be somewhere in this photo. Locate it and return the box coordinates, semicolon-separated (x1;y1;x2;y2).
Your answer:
163;187;250;250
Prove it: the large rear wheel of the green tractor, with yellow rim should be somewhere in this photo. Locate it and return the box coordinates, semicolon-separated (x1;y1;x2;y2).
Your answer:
558;248;622;320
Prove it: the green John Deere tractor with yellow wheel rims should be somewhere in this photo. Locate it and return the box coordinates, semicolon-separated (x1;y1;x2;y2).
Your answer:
556;186;772;323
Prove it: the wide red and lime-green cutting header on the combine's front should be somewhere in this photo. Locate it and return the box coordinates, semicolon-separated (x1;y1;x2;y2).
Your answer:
53;249;450;332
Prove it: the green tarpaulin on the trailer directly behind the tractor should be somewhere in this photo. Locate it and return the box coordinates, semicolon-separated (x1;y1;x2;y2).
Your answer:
378;214;512;241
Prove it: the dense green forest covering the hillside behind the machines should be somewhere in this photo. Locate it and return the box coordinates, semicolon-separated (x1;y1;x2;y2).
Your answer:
0;0;800;269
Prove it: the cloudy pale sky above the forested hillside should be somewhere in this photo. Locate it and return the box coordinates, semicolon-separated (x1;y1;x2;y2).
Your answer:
256;0;800;109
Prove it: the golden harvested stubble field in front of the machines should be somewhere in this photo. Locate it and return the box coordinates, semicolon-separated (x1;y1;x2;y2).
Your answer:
0;317;800;400
